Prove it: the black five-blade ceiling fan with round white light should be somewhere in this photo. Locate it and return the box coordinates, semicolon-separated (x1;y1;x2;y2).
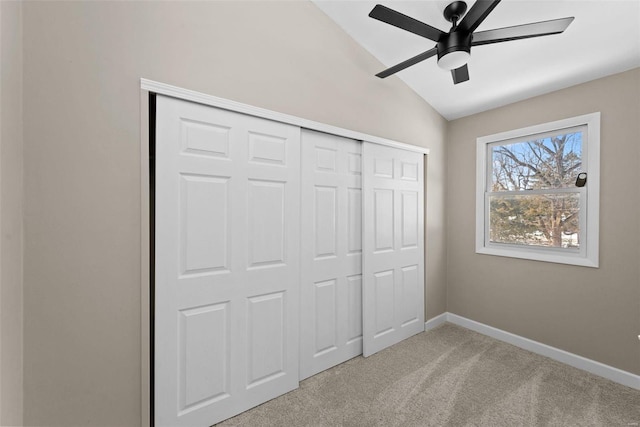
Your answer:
369;0;574;84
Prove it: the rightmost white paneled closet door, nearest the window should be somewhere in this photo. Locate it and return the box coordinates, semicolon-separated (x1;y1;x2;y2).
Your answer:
362;142;424;356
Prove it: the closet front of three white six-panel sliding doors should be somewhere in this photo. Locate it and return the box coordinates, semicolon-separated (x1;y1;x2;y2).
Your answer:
153;95;424;426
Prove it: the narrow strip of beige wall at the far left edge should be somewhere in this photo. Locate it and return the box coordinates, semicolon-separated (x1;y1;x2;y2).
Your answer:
0;1;23;426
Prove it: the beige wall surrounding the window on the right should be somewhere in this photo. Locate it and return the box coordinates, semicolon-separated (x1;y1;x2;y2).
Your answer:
446;69;640;374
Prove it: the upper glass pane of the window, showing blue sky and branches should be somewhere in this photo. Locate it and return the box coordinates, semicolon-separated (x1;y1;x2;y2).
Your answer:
488;131;583;192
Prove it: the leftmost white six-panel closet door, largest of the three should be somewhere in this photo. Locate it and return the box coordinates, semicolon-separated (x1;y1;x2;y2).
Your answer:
154;96;300;426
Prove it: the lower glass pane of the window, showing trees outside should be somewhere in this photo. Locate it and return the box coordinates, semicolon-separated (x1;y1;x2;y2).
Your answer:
489;193;580;248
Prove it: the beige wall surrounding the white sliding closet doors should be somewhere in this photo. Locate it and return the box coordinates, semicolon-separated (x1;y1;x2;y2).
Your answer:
24;1;446;426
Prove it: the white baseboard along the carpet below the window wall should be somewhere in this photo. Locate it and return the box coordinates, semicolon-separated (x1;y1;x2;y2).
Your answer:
425;313;640;390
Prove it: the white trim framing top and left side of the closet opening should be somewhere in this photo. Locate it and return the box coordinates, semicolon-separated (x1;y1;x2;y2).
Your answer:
139;78;429;427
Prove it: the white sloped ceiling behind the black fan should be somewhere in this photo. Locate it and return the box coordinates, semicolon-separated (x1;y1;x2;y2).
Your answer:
314;0;640;120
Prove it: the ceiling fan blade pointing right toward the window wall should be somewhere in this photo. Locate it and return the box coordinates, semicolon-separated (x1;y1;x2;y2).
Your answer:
471;17;574;46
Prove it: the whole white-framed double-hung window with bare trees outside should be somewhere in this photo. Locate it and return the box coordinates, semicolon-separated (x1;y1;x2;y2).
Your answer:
476;113;600;267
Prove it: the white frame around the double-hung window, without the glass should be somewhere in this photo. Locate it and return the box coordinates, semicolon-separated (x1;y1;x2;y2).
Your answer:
476;112;600;268
